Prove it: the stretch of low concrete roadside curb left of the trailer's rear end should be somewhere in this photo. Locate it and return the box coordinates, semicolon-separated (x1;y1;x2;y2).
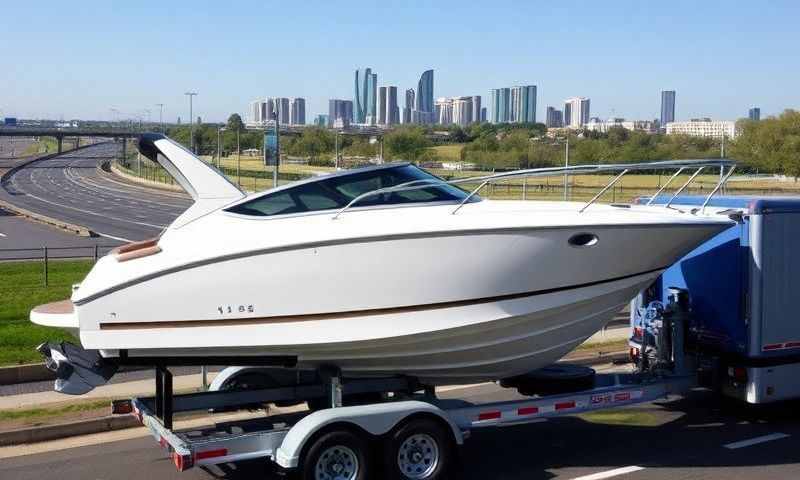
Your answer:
0;415;142;447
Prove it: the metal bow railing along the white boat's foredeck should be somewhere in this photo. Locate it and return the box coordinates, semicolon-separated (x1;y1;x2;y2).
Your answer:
333;158;736;220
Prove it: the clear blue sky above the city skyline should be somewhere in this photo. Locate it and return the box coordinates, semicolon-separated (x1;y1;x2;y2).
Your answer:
0;0;800;121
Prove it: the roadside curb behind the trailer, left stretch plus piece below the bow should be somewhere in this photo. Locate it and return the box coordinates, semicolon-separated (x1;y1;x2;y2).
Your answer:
0;351;628;447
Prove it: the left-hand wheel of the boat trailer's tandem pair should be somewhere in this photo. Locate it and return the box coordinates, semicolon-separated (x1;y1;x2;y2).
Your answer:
302;430;371;480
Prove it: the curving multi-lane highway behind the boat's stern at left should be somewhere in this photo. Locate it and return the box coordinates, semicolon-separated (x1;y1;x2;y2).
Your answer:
0;143;191;241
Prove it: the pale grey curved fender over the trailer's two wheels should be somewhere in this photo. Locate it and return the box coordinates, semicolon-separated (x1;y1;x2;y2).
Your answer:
275;400;464;468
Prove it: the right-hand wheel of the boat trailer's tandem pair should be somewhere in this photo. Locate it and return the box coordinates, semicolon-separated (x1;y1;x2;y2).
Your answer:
384;418;455;480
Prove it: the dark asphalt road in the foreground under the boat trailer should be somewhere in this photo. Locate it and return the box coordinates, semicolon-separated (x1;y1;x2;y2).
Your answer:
0;385;800;480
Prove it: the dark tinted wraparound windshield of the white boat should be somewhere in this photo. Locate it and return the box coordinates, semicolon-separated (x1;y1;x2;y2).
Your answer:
225;165;480;217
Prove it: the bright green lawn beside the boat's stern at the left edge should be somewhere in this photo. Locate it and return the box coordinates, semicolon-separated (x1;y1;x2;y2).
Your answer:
0;260;92;365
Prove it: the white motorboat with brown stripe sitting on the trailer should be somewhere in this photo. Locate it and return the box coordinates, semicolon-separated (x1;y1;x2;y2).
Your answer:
30;134;733;391
